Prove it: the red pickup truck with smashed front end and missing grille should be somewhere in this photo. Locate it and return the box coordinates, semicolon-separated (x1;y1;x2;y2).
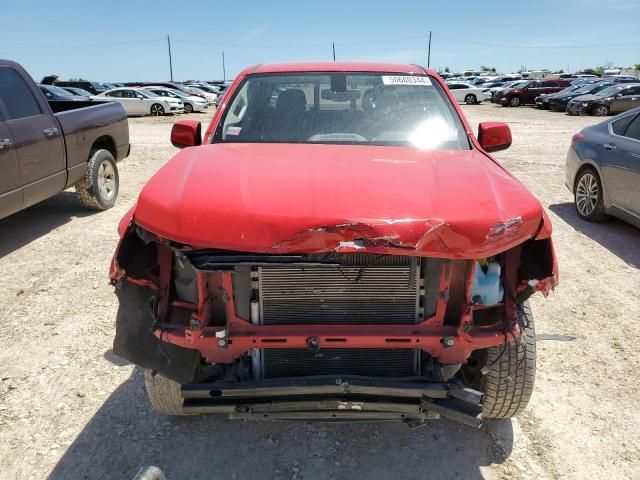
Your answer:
110;62;557;426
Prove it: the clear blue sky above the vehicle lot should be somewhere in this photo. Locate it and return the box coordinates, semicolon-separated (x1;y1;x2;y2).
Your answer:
0;0;640;82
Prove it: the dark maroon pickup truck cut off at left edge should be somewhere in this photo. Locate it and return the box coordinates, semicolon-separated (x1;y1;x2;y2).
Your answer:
0;60;130;218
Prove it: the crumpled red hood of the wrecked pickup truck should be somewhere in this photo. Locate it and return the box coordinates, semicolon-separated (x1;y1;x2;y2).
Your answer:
135;143;542;258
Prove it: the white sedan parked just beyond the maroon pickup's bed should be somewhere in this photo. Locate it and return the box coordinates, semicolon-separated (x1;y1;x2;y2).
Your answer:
91;87;184;116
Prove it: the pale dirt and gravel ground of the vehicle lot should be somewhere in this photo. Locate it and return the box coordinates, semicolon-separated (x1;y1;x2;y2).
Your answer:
0;104;640;480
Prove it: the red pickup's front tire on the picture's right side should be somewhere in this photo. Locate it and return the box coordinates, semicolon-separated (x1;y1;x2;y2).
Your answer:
480;302;536;418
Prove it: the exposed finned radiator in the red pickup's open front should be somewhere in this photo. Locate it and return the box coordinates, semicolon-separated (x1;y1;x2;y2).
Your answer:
254;253;422;378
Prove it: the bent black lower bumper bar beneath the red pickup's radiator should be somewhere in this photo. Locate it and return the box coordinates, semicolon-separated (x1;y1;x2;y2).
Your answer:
181;376;482;428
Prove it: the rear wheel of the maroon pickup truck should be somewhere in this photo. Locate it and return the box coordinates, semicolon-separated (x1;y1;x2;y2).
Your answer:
76;150;120;210
